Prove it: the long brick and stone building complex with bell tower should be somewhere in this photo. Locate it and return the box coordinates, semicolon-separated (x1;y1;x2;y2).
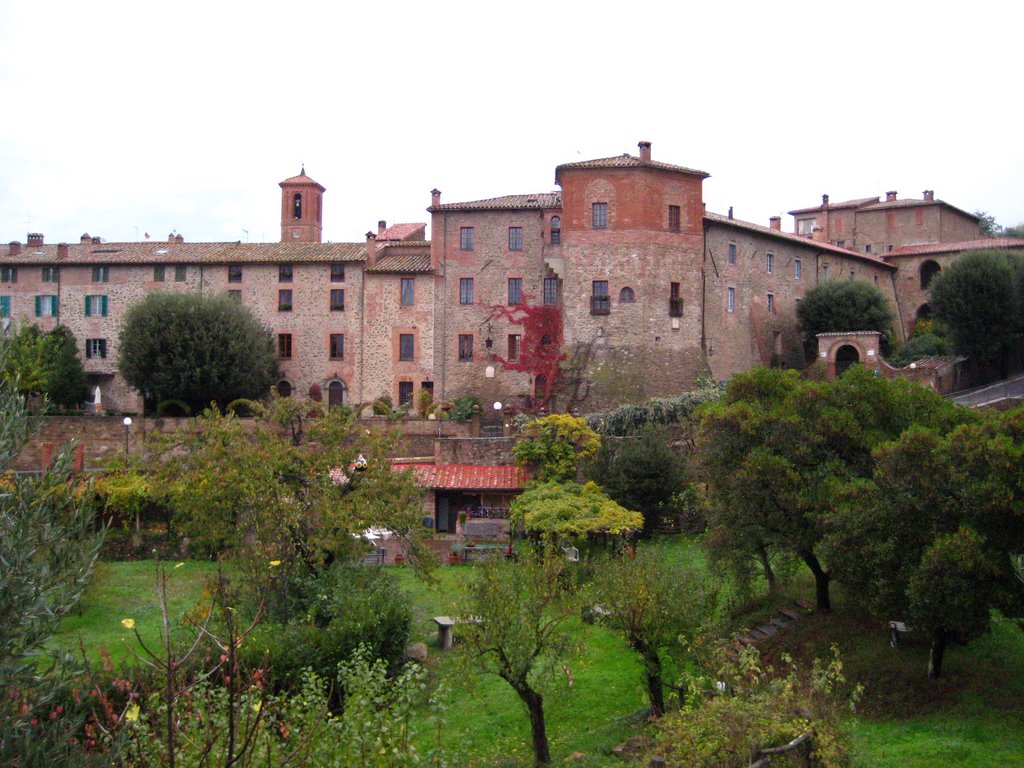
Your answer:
0;141;1024;411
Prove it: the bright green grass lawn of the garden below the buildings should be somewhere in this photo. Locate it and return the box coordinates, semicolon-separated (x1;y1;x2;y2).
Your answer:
49;537;1024;768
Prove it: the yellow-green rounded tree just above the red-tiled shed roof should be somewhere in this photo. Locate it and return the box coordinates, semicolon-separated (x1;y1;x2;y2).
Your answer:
515;414;601;481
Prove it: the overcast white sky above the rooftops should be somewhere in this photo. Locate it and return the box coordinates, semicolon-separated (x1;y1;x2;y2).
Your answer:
0;0;1024;243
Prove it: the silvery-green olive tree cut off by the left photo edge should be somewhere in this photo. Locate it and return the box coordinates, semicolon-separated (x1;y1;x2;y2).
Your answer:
0;350;101;765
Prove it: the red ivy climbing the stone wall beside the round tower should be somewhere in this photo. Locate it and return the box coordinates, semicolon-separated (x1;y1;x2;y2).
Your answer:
487;294;565;408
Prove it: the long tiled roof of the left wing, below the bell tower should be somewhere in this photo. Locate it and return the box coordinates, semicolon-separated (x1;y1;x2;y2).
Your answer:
0;241;367;264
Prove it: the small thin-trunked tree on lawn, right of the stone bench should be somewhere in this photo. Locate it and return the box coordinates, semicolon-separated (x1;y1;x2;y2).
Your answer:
591;547;713;717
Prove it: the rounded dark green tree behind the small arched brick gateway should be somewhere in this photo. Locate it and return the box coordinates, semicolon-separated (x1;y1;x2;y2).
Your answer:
797;280;893;354
